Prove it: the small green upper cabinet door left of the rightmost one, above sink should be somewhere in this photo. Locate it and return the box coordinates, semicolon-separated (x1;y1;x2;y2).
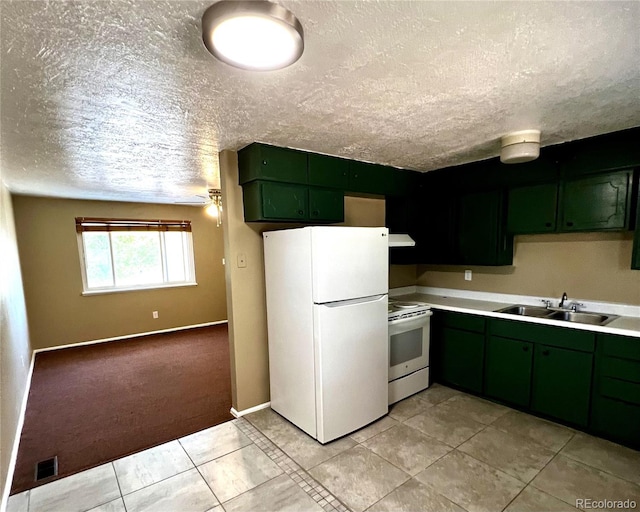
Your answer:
507;183;558;234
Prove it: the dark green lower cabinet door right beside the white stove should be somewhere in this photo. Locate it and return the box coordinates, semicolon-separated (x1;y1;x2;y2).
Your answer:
437;327;484;393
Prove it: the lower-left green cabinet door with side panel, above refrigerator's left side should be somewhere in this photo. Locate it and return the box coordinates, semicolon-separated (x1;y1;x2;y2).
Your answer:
242;181;309;222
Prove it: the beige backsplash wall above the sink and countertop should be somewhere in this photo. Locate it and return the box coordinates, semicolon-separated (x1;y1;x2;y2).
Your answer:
417;232;640;305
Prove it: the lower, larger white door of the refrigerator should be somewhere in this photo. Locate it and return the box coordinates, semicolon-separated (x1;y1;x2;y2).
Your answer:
313;295;389;443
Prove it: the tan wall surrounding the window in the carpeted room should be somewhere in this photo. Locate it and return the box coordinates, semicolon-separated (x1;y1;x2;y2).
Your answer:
13;195;226;349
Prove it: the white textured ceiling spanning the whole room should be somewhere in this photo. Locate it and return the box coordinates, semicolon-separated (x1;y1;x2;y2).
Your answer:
0;0;640;202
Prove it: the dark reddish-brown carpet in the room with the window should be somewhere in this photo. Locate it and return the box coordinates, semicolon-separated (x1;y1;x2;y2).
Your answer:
11;324;232;494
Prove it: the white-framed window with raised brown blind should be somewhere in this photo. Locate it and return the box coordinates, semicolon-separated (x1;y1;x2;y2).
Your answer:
76;217;195;292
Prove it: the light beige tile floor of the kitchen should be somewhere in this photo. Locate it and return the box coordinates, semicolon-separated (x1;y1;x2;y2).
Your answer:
7;384;640;512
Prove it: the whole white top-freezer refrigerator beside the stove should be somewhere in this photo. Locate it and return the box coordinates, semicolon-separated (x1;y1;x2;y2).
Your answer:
263;226;389;443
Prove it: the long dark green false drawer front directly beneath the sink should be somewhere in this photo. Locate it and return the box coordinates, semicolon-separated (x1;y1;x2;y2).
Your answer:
490;319;596;352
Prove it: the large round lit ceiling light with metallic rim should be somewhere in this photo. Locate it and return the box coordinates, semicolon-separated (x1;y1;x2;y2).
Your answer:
202;0;304;71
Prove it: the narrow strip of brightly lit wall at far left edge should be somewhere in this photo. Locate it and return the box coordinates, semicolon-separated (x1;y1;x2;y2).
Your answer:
0;179;31;510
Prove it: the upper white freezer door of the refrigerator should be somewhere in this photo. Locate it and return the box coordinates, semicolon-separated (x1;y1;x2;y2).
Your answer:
311;226;389;304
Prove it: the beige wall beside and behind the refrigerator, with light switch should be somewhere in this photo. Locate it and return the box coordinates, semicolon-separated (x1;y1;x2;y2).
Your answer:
220;151;384;411
